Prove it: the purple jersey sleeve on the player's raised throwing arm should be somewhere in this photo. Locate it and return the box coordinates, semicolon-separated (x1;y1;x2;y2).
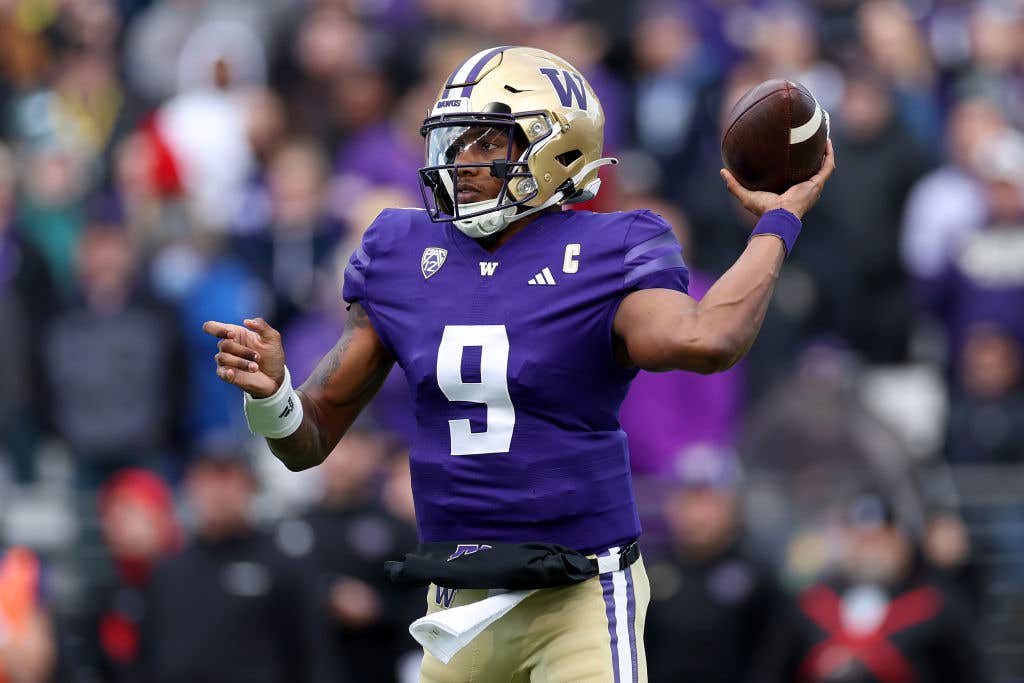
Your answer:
623;210;690;294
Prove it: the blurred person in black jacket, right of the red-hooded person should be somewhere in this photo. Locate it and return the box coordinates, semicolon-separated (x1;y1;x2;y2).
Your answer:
141;447;338;683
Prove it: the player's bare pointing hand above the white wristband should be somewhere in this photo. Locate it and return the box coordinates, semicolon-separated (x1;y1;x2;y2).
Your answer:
203;317;285;398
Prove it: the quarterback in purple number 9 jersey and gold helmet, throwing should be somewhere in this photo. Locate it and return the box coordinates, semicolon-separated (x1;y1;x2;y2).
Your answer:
204;47;835;682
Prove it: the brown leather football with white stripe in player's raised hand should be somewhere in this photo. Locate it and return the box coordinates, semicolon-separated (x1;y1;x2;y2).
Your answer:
722;79;828;194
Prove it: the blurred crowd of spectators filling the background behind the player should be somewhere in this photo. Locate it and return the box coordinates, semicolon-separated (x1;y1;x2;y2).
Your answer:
0;0;1024;683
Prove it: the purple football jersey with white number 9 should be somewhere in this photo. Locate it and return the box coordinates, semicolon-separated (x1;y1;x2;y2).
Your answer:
344;209;688;552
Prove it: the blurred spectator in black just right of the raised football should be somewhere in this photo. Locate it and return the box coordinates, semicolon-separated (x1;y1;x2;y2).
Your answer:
802;70;930;364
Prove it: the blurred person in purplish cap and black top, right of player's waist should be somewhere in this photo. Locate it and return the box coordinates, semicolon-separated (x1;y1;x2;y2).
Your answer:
646;445;778;683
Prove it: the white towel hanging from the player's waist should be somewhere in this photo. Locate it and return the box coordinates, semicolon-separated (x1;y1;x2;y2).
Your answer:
409;591;536;664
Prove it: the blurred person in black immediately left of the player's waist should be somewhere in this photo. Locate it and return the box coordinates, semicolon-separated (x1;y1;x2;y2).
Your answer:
290;431;422;683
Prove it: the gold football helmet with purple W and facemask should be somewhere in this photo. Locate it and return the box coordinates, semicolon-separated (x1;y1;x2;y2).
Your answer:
420;46;616;238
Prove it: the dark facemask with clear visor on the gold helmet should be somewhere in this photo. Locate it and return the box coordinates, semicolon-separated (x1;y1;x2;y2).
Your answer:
420;112;543;239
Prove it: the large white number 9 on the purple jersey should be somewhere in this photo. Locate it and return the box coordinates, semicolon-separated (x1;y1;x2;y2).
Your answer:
437;325;515;456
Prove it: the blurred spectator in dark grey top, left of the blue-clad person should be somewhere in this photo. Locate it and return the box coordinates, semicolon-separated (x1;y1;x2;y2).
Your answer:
41;210;185;490
